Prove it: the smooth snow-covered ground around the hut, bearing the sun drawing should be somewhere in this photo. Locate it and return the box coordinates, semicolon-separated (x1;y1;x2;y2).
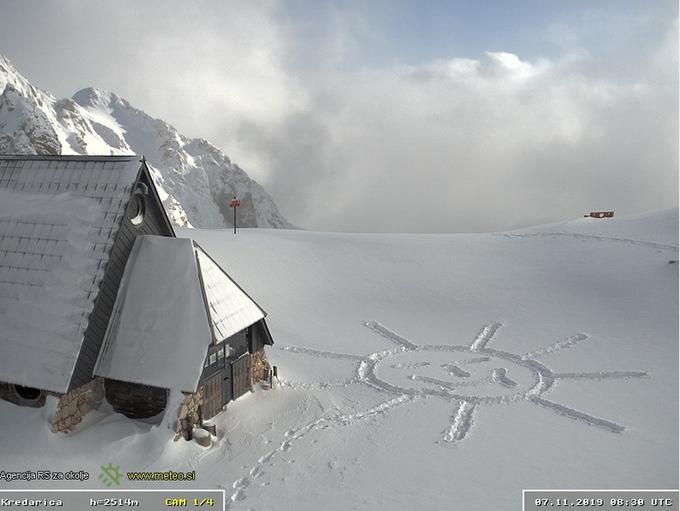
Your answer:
0;210;678;511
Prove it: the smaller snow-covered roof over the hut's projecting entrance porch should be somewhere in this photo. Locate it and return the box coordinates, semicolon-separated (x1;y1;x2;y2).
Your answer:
94;236;264;392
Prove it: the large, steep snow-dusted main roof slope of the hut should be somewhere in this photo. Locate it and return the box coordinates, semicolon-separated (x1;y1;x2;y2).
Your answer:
0;156;140;392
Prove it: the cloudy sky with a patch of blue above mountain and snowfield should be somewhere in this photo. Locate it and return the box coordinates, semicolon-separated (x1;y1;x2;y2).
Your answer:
0;0;678;232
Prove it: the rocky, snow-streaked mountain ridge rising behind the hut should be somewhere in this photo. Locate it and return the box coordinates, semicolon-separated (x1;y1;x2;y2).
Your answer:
0;55;292;228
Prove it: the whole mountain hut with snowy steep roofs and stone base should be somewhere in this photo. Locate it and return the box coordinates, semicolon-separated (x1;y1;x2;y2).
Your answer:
0;156;272;431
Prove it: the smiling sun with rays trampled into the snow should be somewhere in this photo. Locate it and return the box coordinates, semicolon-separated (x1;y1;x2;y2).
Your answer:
282;321;647;442
